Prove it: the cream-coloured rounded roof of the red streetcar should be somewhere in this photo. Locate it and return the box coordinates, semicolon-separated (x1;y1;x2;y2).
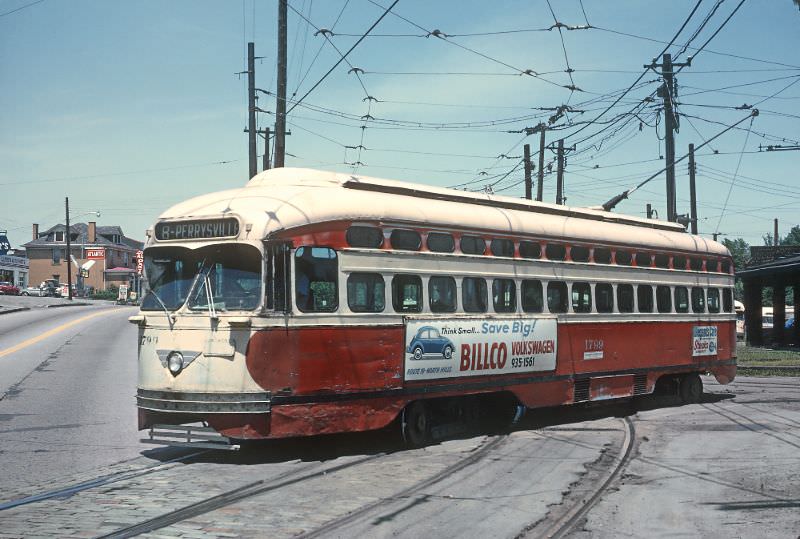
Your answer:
152;168;728;255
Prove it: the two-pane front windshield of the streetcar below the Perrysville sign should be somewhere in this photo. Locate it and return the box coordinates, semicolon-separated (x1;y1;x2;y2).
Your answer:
142;244;262;312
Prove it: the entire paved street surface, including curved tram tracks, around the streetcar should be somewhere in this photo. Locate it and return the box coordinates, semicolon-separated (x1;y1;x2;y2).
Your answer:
0;304;800;539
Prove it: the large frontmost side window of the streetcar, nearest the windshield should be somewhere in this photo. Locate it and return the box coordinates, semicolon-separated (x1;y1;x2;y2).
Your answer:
294;247;339;312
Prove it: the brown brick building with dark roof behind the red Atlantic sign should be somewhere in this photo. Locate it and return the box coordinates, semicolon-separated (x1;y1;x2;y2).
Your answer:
24;222;144;290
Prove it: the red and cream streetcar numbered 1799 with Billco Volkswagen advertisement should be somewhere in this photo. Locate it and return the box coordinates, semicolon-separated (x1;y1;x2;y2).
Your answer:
130;168;736;447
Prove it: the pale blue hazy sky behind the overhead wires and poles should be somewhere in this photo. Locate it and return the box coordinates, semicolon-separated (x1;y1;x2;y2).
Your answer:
0;0;800;247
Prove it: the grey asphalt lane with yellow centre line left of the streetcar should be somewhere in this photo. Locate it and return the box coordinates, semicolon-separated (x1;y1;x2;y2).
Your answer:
0;298;144;496
